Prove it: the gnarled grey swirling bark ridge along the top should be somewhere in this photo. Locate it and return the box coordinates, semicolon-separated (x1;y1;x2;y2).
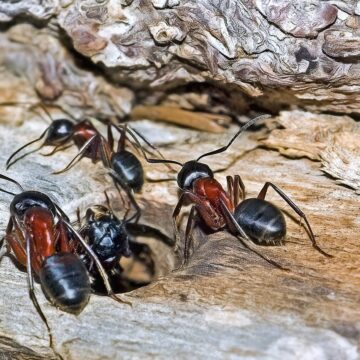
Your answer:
0;0;360;113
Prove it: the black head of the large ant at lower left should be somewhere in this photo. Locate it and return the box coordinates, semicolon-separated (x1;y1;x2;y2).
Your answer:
10;191;56;220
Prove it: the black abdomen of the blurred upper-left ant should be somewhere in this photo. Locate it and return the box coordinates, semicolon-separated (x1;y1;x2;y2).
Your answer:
111;150;144;191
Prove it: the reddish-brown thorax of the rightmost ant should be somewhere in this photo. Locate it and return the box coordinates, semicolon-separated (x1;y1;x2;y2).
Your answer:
193;178;234;230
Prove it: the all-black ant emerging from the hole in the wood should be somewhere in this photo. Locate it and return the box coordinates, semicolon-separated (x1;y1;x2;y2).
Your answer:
77;191;173;292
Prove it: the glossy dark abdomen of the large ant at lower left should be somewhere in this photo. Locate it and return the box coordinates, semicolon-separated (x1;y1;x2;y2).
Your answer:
39;253;91;314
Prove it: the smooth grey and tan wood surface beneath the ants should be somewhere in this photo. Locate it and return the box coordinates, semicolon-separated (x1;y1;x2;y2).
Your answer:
0;111;360;359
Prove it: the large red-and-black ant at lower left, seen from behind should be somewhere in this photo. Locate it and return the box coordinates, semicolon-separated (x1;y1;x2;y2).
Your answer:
0;174;131;340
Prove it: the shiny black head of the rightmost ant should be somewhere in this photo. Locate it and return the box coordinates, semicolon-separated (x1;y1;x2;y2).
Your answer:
177;160;214;190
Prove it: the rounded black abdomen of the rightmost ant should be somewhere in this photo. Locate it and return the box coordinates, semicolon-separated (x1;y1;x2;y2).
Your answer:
234;198;286;245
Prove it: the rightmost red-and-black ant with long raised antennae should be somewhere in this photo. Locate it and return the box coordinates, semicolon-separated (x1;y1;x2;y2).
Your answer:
141;115;332;270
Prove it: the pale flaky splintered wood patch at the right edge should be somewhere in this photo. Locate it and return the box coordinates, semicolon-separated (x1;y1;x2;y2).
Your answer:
262;111;360;193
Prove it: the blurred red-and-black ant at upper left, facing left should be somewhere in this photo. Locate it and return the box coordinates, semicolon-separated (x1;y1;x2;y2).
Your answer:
6;107;162;221
